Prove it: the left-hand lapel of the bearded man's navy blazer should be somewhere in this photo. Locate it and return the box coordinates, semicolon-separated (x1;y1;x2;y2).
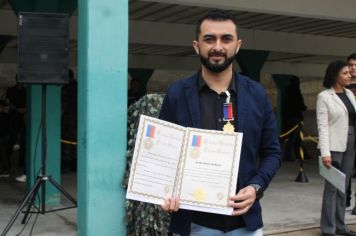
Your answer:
184;74;201;128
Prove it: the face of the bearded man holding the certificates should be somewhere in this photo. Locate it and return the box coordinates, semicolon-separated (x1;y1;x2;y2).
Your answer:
193;20;242;73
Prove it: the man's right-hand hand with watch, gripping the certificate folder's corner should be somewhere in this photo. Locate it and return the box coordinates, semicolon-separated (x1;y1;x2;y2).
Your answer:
229;186;256;216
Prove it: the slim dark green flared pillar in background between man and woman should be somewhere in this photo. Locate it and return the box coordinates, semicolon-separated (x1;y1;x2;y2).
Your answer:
272;74;293;134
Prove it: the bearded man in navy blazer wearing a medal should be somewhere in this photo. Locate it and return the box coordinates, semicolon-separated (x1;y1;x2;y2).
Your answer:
159;10;281;236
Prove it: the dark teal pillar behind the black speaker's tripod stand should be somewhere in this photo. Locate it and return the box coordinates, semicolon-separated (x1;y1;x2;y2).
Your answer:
26;85;61;205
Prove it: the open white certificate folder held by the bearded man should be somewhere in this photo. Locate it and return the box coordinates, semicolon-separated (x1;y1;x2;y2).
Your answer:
126;115;242;215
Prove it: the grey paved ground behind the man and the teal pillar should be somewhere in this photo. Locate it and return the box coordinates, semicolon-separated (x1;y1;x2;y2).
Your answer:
0;142;356;236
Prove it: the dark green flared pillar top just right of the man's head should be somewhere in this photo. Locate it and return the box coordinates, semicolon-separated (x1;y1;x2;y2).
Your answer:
236;49;269;82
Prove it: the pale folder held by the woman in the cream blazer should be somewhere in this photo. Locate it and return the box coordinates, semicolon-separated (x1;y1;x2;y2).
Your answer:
319;157;346;193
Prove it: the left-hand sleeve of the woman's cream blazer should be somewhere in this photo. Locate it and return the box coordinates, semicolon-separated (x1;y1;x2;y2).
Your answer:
316;94;331;157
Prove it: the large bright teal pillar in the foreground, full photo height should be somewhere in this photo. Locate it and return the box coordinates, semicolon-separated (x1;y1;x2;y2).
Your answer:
77;0;128;236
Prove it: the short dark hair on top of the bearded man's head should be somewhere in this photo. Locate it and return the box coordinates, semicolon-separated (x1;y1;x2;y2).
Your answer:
195;9;238;39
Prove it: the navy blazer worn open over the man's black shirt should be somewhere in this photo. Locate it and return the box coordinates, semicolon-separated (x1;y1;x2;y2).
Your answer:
159;73;281;235
